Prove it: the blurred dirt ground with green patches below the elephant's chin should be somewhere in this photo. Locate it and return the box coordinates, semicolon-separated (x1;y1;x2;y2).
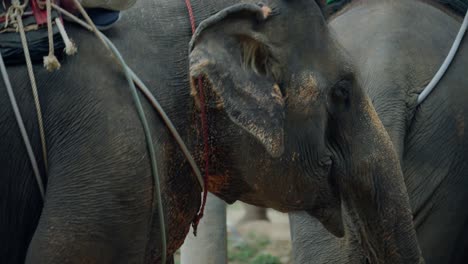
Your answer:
175;202;292;264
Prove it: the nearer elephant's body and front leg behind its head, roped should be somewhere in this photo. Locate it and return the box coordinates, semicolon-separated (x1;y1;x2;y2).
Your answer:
0;0;245;263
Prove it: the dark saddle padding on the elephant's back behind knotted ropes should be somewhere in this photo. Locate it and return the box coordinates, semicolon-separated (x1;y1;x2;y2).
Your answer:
0;0;65;65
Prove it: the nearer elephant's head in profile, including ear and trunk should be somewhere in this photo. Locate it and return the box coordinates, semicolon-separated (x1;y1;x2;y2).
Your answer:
190;0;420;256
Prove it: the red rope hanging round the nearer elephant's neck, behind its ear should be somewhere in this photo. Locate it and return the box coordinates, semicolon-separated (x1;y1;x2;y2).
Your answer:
185;0;210;236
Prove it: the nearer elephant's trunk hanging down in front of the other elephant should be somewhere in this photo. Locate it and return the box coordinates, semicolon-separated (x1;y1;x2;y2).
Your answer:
337;95;424;263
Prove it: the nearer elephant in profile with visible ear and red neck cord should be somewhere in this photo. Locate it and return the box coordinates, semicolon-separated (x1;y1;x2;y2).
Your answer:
0;0;421;264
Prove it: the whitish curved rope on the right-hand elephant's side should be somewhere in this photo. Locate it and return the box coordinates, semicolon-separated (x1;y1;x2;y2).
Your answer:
417;11;468;105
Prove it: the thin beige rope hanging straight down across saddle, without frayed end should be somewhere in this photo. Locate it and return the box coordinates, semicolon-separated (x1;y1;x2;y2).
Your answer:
11;0;48;175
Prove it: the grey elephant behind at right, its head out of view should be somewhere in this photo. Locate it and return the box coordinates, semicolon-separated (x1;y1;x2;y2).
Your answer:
290;0;468;264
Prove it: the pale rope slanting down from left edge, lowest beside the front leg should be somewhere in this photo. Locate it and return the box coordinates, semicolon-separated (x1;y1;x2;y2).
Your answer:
0;49;45;200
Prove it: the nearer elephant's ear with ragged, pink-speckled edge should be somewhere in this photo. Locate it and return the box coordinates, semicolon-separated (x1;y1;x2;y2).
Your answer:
190;4;285;157
